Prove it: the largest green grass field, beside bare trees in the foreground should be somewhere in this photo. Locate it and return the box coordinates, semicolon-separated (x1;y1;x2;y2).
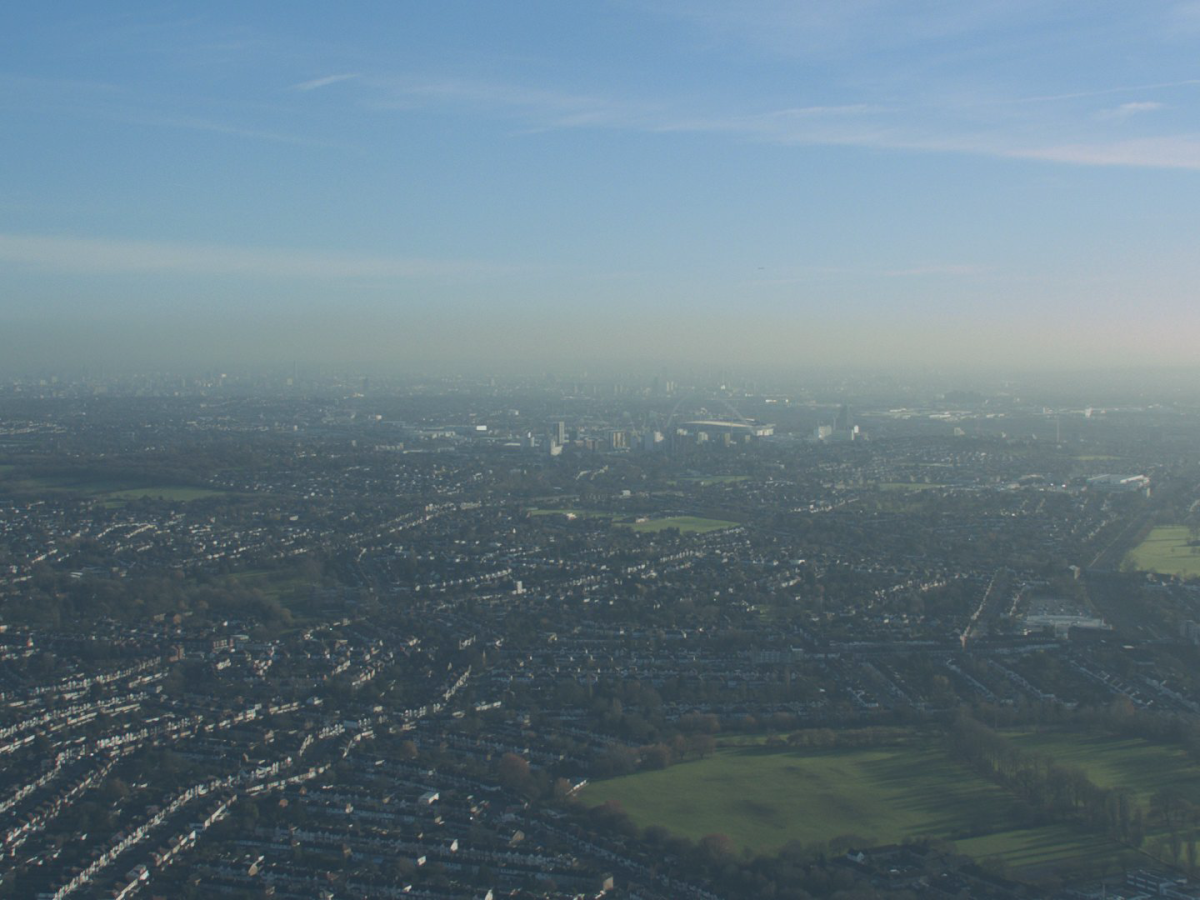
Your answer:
583;745;1015;853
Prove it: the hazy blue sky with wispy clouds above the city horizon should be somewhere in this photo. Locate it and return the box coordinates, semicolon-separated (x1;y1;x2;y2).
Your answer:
0;0;1200;368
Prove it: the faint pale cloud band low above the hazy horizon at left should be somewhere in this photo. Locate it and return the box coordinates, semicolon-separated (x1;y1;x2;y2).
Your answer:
0;234;532;281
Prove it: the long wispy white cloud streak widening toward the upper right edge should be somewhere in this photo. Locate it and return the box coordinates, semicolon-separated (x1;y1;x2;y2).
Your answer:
361;68;1200;169
